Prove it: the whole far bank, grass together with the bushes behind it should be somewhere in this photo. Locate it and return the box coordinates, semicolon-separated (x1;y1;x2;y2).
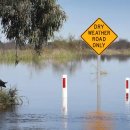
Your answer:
0;35;130;63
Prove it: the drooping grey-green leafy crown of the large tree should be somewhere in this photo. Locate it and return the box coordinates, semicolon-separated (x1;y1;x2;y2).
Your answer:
0;0;66;51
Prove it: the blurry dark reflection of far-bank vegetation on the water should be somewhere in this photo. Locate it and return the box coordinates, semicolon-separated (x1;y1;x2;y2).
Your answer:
28;55;130;74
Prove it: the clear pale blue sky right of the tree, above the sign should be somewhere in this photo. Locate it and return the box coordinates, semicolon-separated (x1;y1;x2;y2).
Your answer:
58;0;130;41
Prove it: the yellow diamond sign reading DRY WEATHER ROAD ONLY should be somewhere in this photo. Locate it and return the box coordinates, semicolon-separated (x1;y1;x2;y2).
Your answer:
81;18;118;55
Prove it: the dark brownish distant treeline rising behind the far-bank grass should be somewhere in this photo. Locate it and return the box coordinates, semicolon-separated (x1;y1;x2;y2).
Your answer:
0;38;130;50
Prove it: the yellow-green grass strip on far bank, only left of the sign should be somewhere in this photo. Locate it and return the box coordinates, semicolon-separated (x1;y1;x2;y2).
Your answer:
0;48;89;63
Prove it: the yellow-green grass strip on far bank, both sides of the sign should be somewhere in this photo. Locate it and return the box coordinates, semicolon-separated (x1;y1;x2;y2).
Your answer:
0;48;130;63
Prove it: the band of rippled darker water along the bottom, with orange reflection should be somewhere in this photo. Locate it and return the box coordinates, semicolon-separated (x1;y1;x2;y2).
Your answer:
0;112;130;130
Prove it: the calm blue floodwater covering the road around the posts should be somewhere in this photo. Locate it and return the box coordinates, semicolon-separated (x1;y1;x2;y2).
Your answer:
0;57;130;130
